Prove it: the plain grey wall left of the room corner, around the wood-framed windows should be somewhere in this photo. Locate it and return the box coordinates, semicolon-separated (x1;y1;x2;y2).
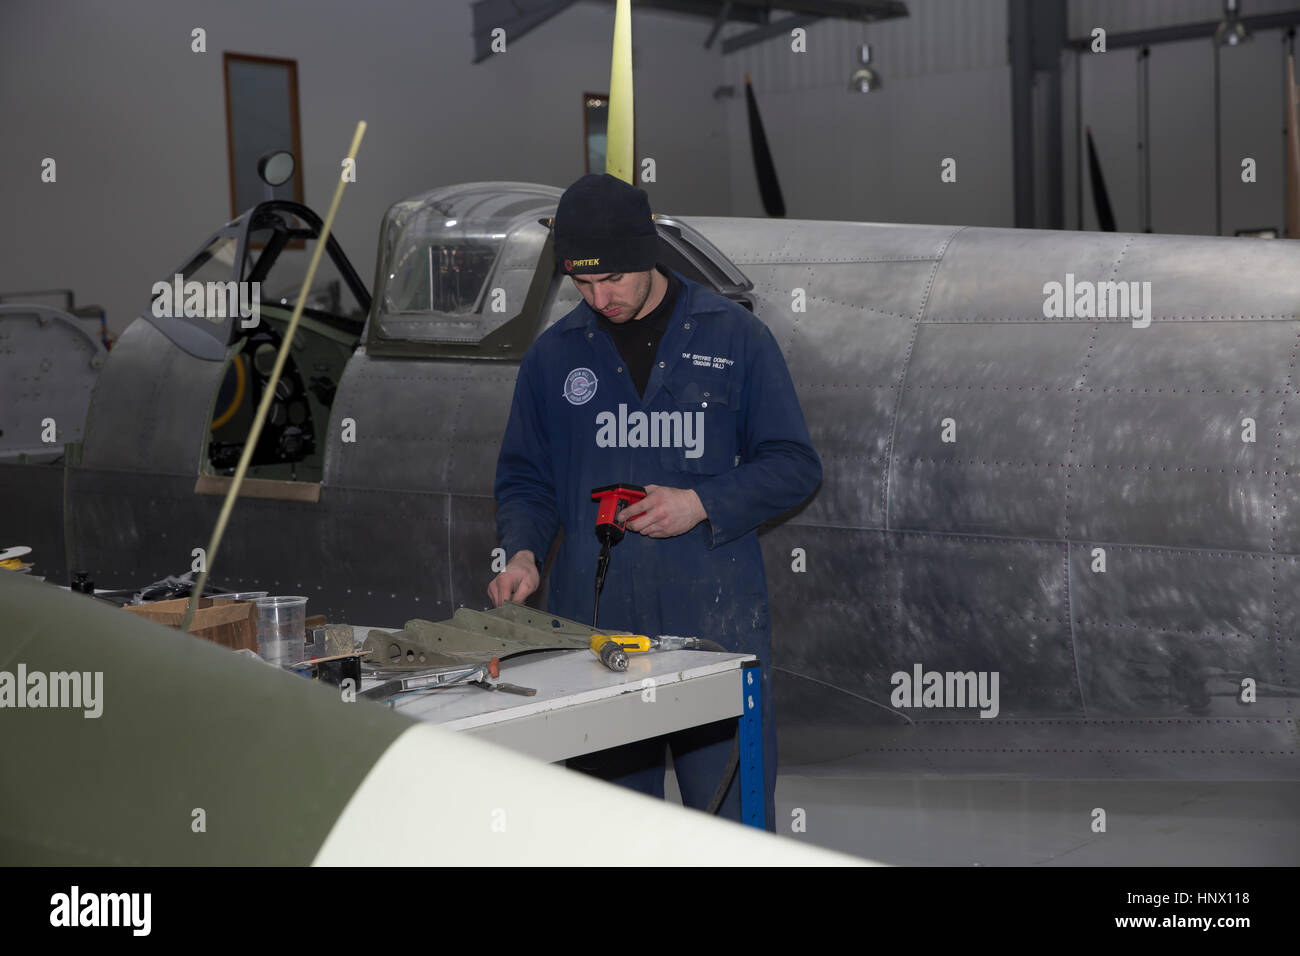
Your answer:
0;0;731;332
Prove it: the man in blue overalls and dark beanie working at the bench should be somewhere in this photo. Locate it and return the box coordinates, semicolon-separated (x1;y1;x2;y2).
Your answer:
488;174;822;830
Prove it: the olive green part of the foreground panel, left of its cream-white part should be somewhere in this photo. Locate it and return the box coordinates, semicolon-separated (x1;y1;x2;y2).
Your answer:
0;571;412;865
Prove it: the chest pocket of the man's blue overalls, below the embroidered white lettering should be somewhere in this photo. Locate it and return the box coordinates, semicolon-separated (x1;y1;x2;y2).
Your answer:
659;371;740;475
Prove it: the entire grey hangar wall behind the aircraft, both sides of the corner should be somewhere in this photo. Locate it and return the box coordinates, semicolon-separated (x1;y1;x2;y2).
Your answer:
0;0;1300;332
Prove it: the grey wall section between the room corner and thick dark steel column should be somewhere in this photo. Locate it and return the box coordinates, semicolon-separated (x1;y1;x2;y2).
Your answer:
724;0;1014;226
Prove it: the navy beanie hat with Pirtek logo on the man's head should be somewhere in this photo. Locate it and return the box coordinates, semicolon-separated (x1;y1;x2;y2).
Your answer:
555;173;659;276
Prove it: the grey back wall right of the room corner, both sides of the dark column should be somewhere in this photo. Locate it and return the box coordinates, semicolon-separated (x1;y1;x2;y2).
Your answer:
724;0;1300;235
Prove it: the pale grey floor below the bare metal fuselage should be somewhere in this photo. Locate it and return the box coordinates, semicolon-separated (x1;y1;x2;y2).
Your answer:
666;771;1300;866
